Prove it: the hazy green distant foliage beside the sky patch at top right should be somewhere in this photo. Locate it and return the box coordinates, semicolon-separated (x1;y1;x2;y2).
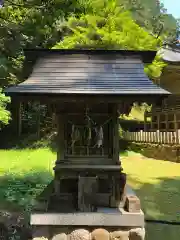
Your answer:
122;0;177;41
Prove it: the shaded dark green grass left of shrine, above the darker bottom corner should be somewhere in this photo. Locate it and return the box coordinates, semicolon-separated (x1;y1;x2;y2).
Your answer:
0;170;53;213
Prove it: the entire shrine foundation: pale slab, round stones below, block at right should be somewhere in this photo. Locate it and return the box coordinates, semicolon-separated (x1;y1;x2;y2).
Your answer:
30;185;145;240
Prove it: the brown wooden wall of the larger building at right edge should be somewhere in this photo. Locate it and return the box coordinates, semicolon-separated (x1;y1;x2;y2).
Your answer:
144;65;180;132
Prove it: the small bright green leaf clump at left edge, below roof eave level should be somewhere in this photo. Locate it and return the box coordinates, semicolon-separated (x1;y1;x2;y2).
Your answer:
0;89;10;128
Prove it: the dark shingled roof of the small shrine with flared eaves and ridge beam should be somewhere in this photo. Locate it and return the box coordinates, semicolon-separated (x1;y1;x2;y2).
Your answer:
6;49;169;95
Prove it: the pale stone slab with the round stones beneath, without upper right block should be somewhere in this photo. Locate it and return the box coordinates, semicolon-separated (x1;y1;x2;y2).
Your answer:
31;205;145;240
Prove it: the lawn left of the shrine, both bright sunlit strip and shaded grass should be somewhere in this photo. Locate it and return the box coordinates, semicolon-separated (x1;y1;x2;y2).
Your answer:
0;148;56;211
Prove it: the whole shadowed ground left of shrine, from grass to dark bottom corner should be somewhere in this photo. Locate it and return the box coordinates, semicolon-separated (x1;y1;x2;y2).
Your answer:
0;169;53;239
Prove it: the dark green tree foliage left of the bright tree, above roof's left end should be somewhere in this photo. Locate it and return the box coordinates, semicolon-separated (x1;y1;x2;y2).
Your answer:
0;0;87;87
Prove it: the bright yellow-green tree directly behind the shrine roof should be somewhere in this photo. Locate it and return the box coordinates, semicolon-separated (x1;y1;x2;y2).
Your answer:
53;0;164;77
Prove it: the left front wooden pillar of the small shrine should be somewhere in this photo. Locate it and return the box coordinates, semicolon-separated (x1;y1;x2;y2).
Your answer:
57;113;65;161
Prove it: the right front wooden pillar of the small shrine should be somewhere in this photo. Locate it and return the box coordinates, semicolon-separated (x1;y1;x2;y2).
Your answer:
113;104;119;163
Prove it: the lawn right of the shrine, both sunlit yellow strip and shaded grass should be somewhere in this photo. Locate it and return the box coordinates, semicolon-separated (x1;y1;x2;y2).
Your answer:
121;152;180;240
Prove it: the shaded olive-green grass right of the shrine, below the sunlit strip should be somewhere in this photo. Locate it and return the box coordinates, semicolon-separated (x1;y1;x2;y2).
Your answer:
128;176;180;240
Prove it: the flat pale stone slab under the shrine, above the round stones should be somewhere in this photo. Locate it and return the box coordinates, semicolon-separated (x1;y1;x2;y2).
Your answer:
31;208;144;227
